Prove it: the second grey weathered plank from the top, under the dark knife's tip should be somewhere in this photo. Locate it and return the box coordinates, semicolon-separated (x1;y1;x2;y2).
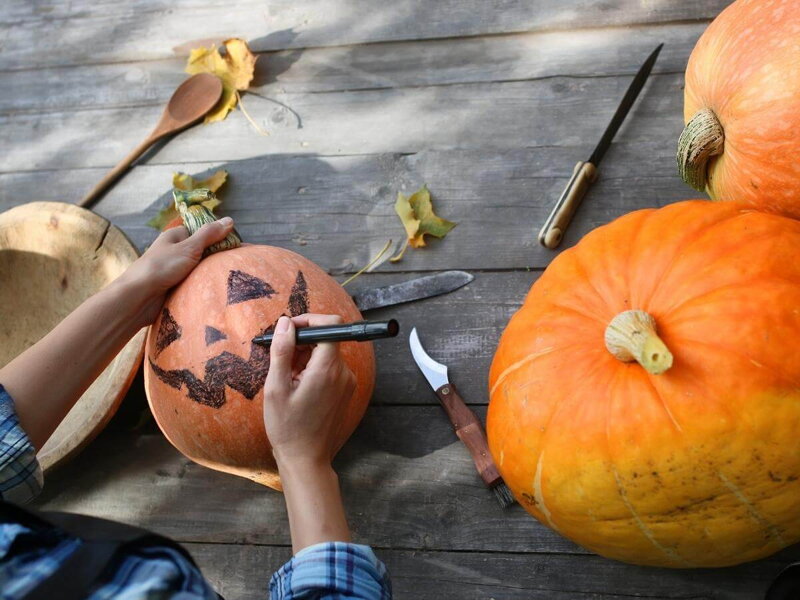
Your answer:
0;23;706;114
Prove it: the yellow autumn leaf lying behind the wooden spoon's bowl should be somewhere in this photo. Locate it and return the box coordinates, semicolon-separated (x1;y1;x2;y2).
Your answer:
186;38;258;123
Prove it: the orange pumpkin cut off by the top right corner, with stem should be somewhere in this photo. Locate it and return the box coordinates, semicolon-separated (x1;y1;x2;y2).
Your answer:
678;0;800;218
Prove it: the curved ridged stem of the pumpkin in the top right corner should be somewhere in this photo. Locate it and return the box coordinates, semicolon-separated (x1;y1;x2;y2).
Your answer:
677;108;725;192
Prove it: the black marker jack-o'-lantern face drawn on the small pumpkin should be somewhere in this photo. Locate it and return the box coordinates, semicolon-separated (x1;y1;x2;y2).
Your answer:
148;271;310;408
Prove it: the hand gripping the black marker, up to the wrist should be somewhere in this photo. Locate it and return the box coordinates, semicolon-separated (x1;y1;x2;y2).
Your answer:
264;314;356;470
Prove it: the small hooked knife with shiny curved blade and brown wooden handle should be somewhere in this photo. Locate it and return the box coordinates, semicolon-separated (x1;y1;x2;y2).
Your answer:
408;327;515;508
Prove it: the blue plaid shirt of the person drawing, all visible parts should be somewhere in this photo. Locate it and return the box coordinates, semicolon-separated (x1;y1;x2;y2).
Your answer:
0;385;392;600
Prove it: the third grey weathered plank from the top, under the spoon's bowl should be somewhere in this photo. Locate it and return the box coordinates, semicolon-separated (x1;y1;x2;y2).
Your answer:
0;74;683;172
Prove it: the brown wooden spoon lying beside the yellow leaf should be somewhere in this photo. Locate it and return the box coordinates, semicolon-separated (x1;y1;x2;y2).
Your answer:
78;73;222;207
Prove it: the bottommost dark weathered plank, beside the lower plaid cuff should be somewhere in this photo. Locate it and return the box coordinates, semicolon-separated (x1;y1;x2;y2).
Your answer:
187;544;788;600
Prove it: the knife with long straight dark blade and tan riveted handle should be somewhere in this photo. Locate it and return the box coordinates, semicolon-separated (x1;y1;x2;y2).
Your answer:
539;44;664;249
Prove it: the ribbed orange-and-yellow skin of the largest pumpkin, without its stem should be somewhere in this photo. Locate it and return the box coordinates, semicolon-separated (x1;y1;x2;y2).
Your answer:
487;201;800;567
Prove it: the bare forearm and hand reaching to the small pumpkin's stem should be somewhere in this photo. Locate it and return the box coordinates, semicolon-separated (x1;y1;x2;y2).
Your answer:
0;220;238;448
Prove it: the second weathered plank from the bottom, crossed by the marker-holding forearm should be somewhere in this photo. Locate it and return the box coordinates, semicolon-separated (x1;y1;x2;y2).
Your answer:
37;406;583;553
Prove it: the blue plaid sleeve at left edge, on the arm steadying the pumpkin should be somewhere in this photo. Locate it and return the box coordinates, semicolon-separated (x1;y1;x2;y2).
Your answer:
0;385;43;504
